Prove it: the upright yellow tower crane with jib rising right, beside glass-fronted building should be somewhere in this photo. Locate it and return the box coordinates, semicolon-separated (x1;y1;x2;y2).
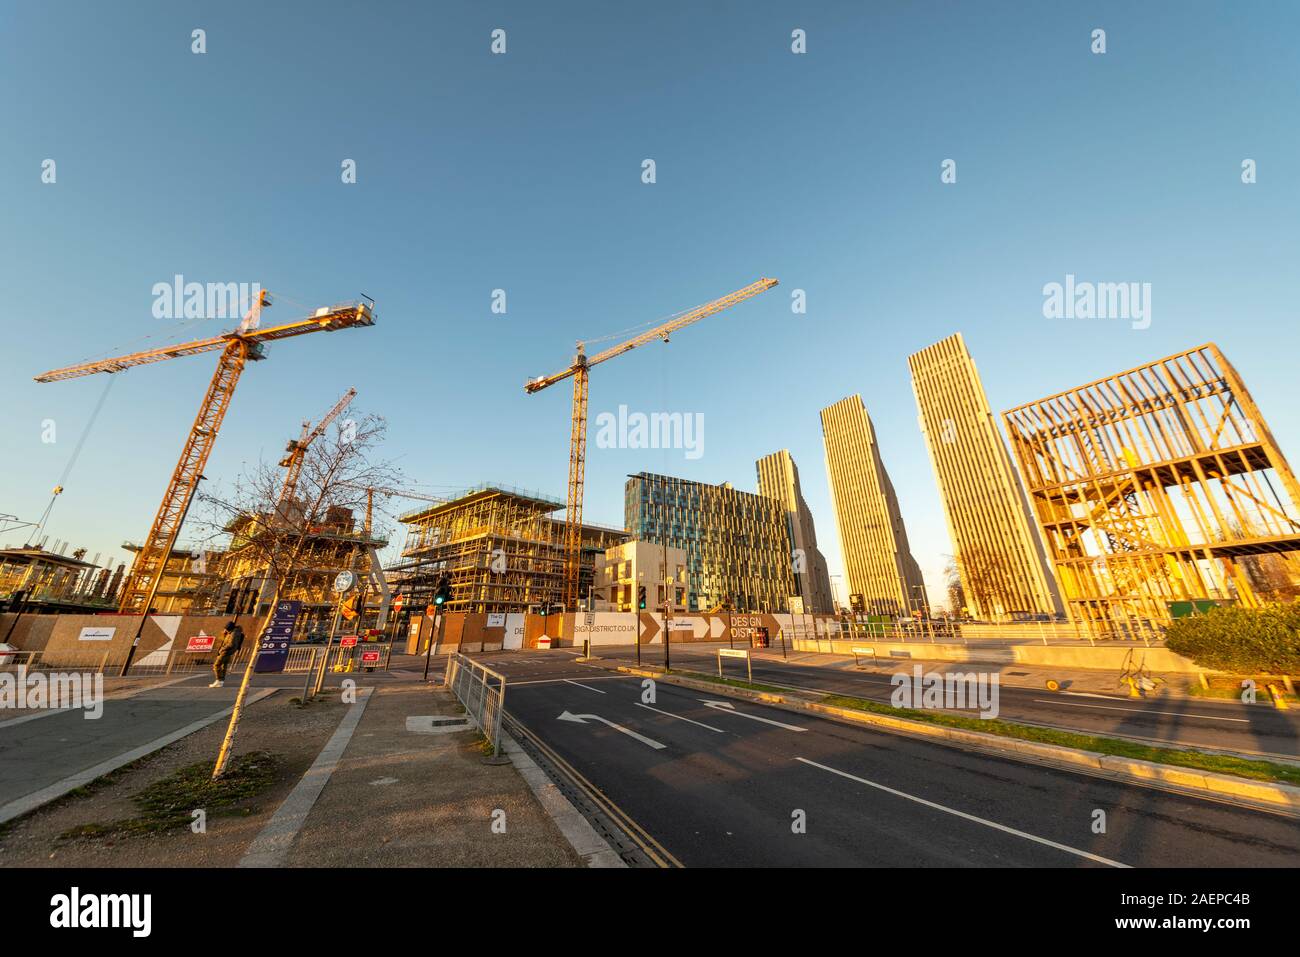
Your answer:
524;278;777;611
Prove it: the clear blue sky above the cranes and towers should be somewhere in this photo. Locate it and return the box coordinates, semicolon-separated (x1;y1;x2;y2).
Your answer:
0;0;1300;608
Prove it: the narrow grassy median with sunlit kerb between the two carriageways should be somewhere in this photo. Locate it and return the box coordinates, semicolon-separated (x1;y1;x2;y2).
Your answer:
618;666;1300;817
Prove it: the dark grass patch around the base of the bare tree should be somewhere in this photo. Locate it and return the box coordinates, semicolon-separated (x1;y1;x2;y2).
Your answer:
60;752;280;840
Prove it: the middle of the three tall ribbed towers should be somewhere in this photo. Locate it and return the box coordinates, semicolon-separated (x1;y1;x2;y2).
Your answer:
822;395;930;615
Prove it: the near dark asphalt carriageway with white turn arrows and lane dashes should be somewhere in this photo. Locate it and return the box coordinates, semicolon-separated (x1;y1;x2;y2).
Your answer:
484;653;1300;867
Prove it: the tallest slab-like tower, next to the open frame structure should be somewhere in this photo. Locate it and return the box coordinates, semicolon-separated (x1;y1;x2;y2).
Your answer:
907;333;1063;619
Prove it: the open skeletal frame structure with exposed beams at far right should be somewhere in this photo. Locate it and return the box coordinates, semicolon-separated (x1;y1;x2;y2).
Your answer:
1004;343;1300;633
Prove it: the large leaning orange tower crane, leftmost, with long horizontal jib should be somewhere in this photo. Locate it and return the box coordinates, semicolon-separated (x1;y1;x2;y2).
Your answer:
36;290;374;620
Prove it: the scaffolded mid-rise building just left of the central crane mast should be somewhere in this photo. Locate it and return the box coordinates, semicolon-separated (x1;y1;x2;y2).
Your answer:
387;485;631;612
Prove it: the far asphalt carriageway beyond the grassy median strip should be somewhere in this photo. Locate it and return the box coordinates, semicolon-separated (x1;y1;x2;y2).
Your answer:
595;645;1300;761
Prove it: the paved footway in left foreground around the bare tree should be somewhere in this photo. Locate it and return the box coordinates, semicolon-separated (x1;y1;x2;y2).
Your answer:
0;655;587;867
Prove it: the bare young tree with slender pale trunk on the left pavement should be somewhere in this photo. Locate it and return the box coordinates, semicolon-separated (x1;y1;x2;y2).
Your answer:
196;415;402;780
